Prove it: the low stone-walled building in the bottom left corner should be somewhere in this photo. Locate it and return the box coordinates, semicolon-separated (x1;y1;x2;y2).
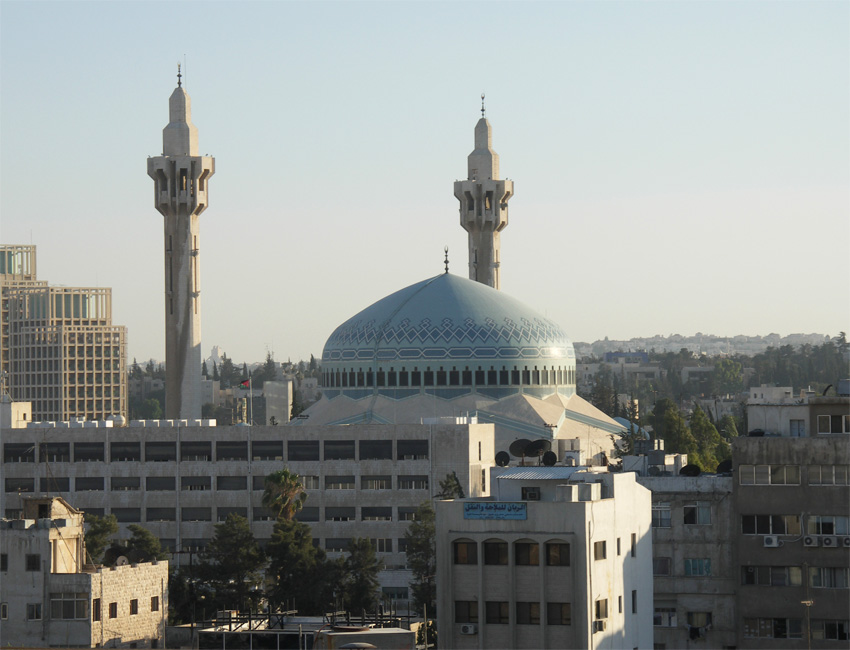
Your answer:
0;497;168;648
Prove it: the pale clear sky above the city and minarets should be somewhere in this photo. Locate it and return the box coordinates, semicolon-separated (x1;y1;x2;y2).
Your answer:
0;0;850;361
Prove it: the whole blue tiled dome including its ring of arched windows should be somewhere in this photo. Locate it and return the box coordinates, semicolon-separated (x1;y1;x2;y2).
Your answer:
322;273;575;397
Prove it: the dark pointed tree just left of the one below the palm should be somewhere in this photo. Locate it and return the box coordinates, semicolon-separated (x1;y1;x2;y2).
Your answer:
198;512;265;611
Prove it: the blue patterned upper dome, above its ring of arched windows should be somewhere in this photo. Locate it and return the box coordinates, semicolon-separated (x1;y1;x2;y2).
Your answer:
322;273;575;365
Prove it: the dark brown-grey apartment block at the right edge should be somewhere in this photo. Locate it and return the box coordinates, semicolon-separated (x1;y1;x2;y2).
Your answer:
732;432;850;649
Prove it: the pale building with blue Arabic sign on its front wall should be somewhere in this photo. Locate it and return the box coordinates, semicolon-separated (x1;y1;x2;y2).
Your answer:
436;466;653;648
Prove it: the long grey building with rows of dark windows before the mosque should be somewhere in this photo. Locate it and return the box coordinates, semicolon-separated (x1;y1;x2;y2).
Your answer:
0;412;495;601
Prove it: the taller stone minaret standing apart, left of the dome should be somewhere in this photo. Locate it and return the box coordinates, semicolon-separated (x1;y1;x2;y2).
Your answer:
148;65;215;420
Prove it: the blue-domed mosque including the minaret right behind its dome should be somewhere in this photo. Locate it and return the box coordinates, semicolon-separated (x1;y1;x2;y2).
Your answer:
296;96;624;463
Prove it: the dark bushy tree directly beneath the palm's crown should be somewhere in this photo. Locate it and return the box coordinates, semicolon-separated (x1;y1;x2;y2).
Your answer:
266;519;344;615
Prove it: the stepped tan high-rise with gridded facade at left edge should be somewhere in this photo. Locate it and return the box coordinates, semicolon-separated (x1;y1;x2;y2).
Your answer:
0;245;127;421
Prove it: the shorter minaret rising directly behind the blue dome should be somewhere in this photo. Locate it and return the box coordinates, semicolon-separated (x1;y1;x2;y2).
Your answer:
455;95;514;289
